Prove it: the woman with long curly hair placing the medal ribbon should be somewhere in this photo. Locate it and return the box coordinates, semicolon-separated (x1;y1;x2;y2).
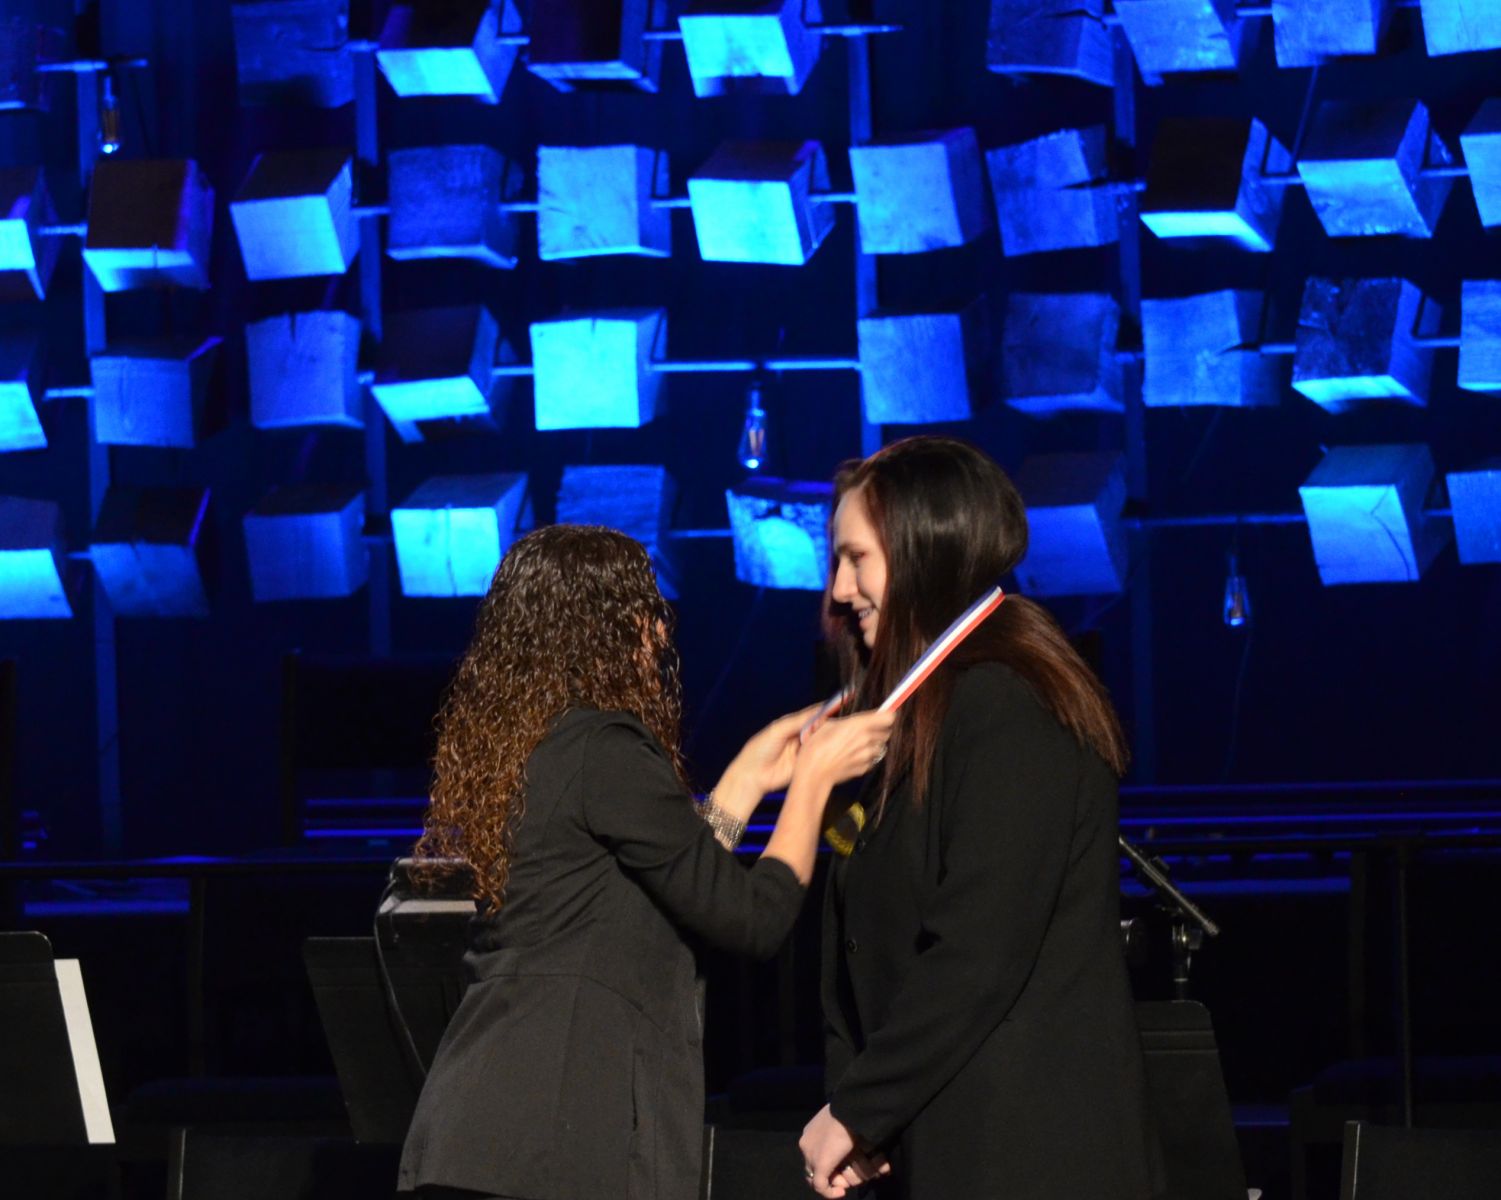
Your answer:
399;526;890;1200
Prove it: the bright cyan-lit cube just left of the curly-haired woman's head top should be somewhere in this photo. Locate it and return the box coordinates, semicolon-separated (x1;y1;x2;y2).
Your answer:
390;475;527;596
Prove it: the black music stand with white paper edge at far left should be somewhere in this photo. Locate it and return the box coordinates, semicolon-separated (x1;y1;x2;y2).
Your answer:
0;933;114;1146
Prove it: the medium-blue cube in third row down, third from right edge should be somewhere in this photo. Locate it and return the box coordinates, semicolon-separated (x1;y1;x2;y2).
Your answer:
1141;291;1279;409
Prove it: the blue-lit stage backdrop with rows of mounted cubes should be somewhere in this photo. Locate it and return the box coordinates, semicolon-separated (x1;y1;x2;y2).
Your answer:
0;0;1501;855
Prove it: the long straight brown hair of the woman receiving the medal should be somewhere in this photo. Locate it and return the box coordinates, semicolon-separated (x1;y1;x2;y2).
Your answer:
824;437;1129;808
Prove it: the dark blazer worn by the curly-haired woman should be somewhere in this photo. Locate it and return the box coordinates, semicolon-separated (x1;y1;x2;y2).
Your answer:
399;709;803;1200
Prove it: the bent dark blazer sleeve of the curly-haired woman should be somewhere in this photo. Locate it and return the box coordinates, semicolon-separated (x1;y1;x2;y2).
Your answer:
581;716;805;958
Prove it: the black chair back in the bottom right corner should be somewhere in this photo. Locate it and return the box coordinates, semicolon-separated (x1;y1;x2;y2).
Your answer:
1339;1120;1501;1200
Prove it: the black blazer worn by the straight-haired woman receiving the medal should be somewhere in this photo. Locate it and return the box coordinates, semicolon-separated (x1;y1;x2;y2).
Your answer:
823;664;1154;1200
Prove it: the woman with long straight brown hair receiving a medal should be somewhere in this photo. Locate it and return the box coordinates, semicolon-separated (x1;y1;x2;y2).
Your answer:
802;437;1154;1200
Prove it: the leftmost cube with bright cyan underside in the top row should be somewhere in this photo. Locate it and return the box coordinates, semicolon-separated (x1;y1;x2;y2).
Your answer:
375;0;521;104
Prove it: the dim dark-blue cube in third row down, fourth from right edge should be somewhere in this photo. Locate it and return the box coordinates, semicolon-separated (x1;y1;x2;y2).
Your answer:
1001;291;1123;416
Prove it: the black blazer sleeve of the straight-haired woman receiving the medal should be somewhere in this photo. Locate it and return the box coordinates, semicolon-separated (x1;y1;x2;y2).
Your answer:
830;665;1082;1144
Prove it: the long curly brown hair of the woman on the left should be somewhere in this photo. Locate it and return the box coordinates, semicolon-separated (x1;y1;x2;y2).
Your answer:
413;526;683;912
